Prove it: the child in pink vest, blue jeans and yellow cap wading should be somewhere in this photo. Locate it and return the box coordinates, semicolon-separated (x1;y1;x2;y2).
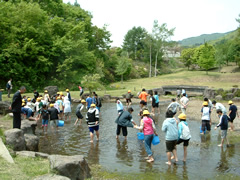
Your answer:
134;110;157;162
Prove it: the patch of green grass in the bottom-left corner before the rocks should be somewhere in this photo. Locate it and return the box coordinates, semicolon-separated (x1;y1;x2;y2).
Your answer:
0;156;50;180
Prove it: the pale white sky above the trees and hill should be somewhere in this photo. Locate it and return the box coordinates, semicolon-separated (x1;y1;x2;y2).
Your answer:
63;0;240;47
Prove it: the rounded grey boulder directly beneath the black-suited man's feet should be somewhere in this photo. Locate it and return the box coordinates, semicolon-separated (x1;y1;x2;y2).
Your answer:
4;128;26;151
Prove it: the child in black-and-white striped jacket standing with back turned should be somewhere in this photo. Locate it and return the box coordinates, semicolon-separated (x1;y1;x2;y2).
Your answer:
86;104;99;143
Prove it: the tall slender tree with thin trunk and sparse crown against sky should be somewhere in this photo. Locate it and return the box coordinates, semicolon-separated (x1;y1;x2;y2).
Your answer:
152;20;175;77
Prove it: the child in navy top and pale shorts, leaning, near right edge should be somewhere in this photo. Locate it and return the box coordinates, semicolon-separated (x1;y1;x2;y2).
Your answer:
214;109;229;147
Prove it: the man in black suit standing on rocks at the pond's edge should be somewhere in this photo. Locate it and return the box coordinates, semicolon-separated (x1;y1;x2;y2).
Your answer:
10;86;26;129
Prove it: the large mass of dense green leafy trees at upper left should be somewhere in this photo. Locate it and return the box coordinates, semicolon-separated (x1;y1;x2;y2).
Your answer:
0;0;111;90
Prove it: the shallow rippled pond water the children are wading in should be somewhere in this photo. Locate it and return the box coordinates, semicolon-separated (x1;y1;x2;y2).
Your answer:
37;103;240;179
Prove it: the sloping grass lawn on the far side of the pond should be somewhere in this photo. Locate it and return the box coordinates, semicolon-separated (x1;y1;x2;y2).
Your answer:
0;70;240;101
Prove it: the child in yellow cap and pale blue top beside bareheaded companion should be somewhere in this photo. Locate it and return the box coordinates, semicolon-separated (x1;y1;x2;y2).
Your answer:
172;113;191;162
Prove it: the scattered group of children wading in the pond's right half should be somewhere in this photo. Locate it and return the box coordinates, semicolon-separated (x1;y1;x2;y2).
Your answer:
115;89;239;165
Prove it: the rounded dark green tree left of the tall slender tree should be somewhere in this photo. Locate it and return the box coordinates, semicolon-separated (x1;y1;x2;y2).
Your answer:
123;26;147;60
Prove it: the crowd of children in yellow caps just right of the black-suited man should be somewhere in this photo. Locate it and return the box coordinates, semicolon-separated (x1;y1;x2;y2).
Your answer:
21;89;71;132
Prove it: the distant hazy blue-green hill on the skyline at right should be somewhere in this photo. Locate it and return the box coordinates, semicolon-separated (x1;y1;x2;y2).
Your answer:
179;31;233;46
